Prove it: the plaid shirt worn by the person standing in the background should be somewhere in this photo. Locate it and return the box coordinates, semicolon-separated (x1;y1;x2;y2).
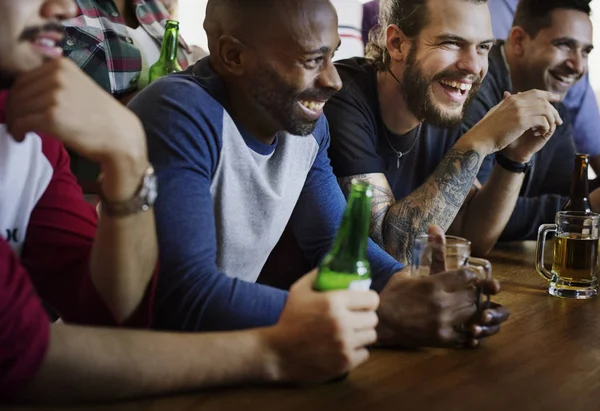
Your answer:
62;0;191;97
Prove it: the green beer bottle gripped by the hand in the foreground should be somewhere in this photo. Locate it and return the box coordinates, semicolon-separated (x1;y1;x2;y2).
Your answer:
314;181;373;291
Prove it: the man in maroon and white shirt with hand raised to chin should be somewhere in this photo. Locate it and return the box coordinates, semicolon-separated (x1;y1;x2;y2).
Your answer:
0;0;378;402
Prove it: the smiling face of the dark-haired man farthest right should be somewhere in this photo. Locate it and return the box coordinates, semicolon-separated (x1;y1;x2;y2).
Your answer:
511;9;593;97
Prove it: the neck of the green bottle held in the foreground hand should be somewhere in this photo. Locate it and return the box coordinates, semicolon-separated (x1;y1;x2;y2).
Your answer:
331;187;371;261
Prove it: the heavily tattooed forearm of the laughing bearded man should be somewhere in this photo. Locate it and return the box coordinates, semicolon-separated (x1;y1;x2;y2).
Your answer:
380;149;480;263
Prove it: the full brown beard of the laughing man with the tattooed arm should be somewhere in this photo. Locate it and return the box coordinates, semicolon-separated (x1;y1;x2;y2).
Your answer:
401;45;481;127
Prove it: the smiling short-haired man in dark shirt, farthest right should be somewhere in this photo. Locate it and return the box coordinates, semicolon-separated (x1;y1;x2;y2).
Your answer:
463;0;600;241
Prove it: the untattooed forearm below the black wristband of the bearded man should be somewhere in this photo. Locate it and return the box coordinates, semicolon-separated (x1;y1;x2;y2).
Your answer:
461;165;525;256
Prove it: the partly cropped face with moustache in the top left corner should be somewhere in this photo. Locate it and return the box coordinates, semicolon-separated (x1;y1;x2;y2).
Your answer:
0;0;76;85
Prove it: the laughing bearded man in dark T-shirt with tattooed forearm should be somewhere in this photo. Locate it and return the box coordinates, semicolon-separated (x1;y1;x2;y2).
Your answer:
325;0;562;261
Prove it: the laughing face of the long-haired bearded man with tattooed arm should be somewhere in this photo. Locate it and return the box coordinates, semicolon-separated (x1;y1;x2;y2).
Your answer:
394;0;493;126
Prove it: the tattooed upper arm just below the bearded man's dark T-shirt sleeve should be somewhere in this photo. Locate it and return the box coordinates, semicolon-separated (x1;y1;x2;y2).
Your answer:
338;174;395;248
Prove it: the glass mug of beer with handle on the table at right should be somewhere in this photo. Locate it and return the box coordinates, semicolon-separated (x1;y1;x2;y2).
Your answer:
535;211;600;299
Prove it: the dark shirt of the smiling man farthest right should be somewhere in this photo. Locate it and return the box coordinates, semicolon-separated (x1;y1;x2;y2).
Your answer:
463;42;575;241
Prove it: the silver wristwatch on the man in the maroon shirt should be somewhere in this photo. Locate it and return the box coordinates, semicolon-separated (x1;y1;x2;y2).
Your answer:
99;164;158;217
